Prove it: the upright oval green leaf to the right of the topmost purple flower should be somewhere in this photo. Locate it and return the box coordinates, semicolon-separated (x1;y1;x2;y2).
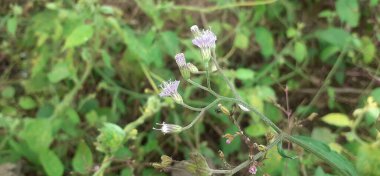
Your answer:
255;27;274;59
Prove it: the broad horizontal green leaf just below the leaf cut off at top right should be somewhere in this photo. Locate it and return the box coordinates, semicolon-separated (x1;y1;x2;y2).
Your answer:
315;27;351;48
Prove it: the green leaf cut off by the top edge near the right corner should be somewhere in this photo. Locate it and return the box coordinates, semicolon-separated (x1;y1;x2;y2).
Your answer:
335;0;360;27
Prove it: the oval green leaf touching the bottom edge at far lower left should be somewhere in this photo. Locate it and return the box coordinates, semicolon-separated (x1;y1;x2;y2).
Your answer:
39;150;64;176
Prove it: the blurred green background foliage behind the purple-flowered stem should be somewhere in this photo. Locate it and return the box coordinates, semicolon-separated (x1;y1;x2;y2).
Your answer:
0;0;380;176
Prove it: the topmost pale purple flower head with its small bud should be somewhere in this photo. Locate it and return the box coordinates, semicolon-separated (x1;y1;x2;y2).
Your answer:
191;26;216;61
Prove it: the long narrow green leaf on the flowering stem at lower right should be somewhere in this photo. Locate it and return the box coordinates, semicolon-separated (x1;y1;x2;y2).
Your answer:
291;136;358;176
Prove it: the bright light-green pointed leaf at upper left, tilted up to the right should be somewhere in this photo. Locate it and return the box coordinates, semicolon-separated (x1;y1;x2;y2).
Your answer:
63;24;94;49
